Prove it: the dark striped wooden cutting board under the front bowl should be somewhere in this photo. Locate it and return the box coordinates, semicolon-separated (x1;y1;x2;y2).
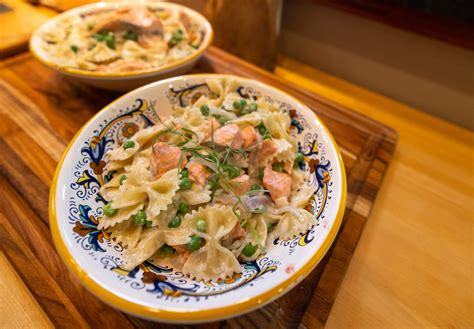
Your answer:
0;47;397;328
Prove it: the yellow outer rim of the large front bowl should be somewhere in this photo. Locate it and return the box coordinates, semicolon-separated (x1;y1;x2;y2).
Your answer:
49;74;347;323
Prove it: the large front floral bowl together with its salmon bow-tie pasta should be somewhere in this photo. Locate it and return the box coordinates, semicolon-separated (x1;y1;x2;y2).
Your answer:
50;74;346;323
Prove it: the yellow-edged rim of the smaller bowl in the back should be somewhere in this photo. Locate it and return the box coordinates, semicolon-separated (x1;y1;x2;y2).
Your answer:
28;2;214;79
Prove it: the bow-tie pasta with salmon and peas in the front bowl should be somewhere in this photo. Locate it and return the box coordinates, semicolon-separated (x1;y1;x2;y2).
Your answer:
99;77;315;281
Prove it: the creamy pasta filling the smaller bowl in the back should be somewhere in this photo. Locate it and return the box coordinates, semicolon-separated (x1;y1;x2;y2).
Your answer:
40;5;205;72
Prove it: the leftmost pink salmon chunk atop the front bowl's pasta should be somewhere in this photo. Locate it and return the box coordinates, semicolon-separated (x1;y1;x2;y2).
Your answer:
150;142;188;177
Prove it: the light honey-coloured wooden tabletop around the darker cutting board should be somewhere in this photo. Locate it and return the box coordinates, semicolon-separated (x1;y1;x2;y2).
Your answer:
0;52;474;328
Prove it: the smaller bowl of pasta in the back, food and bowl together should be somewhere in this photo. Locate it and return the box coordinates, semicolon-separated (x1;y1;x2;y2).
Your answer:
30;1;213;91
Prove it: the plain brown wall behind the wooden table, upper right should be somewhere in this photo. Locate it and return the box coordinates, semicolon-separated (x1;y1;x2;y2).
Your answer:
280;0;474;130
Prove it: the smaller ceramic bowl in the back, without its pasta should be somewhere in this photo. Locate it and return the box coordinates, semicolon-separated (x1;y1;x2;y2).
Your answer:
29;1;214;91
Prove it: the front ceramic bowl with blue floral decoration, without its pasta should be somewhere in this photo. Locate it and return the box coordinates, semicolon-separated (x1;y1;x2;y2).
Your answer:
50;74;346;323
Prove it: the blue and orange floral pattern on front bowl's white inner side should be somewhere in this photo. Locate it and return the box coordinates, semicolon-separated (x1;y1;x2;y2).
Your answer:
53;76;345;320
